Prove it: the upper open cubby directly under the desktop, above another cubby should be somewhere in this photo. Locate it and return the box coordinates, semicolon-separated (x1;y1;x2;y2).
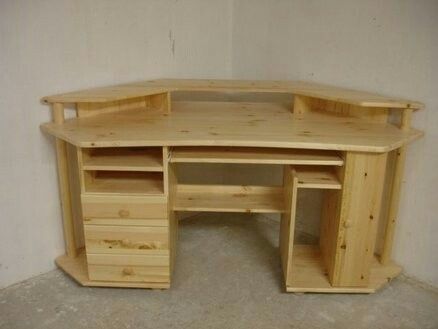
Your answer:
83;147;163;171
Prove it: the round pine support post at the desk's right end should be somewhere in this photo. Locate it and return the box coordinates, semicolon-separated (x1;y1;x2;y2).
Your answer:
380;109;413;264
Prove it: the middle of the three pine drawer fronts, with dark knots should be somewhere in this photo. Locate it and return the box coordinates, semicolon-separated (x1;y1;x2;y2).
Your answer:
84;224;169;255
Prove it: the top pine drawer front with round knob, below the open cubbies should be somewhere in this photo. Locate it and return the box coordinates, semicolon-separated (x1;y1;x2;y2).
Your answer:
81;194;167;220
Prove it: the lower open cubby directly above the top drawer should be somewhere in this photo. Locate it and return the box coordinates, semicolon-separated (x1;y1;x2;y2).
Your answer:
85;171;164;194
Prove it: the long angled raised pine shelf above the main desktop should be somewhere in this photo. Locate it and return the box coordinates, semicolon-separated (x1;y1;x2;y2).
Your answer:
43;79;423;109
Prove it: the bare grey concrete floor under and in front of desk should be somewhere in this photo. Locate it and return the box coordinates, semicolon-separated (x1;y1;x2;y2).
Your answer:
0;214;438;329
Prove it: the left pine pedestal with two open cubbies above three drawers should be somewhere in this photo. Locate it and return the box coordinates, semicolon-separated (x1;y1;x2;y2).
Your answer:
79;147;170;287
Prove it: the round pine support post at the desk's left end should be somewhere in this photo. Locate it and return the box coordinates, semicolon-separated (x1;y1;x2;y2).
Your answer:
52;103;77;257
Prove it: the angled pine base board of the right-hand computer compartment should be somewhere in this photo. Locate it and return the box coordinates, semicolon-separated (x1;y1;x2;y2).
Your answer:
286;245;401;293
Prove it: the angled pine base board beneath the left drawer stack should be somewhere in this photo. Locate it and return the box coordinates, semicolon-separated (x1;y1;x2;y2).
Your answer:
55;252;170;289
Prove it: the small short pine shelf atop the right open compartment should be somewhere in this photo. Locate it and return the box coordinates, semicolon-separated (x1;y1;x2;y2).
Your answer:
296;167;342;190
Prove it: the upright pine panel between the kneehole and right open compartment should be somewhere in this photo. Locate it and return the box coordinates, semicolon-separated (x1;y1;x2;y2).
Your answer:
279;166;298;285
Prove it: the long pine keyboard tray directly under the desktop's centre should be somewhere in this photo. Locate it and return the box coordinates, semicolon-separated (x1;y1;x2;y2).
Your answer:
170;146;344;166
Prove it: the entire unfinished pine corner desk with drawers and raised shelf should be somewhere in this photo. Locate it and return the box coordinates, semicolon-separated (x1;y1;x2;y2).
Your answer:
41;80;422;293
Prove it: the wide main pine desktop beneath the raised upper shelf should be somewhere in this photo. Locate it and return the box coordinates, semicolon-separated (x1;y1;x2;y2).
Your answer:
42;101;422;152
